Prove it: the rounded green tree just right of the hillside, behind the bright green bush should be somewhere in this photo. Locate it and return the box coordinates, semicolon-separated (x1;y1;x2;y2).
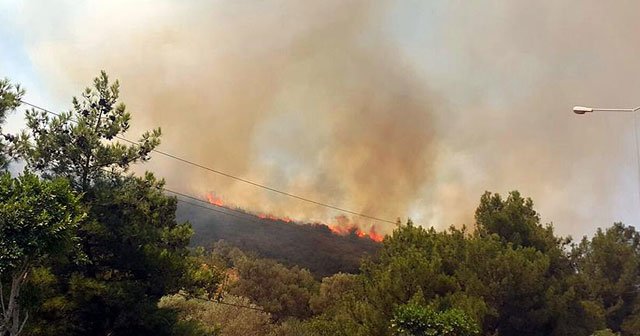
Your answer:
344;222;476;335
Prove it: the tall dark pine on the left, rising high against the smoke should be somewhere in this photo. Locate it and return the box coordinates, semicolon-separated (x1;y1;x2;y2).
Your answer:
11;72;209;335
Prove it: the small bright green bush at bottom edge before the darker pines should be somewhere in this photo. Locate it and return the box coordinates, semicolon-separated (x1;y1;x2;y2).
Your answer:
390;304;480;336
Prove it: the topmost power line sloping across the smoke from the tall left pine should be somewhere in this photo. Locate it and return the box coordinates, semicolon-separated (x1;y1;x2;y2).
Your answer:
21;100;396;224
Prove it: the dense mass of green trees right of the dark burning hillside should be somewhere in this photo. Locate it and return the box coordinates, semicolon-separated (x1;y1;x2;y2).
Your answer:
150;192;640;336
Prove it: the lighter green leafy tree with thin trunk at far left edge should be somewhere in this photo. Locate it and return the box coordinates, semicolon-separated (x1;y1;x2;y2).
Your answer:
0;172;84;335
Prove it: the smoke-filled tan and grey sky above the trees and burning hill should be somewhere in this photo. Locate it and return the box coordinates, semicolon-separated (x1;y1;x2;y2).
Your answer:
0;0;640;236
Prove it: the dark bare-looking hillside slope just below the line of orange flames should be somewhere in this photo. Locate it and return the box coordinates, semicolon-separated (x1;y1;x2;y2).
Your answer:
177;203;381;277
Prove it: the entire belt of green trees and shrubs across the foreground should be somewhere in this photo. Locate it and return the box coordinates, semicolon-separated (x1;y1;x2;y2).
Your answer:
0;72;640;336
